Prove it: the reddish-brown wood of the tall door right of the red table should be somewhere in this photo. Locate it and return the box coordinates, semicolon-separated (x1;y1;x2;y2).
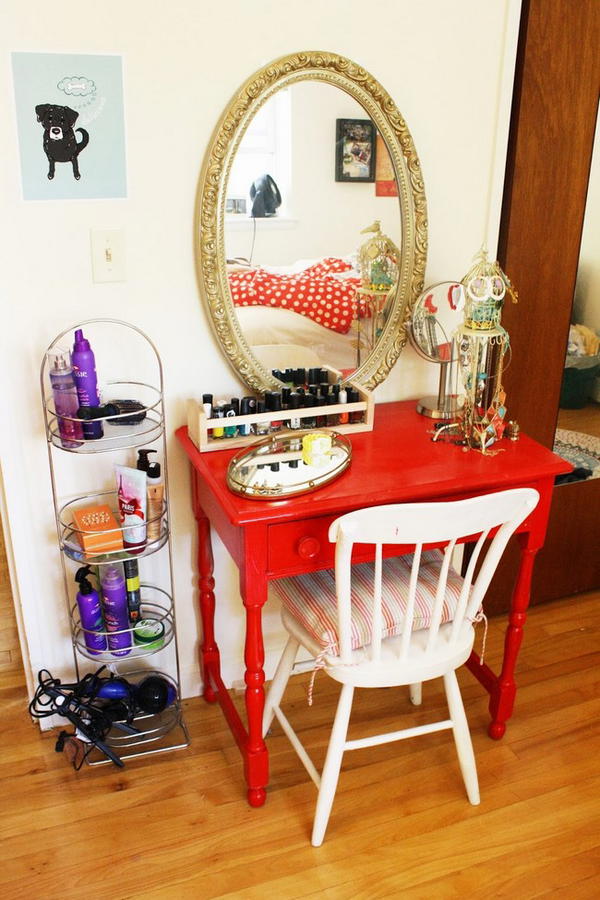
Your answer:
486;0;600;613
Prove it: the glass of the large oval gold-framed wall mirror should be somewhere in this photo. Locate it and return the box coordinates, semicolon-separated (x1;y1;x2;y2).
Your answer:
224;81;402;374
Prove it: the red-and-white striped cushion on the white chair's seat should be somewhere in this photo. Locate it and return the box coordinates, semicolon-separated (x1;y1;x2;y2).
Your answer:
271;550;463;654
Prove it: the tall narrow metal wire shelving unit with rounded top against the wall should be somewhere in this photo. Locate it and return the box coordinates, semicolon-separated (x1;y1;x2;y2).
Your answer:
40;319;190;765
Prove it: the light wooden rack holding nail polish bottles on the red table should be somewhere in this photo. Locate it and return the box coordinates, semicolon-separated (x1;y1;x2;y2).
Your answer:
188;367;374;452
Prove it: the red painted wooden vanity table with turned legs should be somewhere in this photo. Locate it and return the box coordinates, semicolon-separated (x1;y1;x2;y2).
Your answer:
177;400;571;806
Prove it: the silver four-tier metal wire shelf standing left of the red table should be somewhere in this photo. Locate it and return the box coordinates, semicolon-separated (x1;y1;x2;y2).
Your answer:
40;319;189;765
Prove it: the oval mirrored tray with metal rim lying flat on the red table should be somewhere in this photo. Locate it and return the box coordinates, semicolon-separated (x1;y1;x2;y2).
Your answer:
227;429;352;500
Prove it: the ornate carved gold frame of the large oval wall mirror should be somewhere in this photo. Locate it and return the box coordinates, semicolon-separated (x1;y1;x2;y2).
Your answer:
195;51;427;391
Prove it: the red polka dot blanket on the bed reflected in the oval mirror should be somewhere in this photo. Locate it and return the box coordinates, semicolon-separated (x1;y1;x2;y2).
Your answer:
228;257;360;334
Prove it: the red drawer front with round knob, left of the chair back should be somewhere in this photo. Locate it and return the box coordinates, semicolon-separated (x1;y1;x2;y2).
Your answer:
268;516;337;575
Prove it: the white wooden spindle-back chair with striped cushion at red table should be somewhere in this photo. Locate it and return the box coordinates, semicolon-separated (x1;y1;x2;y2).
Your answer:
263;488;539;847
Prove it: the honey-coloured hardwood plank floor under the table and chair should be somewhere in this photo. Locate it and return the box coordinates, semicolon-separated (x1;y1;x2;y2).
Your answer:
0;592;600;900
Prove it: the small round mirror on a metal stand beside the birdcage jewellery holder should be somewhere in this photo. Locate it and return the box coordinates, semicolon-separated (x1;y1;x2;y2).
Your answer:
409;281;465;419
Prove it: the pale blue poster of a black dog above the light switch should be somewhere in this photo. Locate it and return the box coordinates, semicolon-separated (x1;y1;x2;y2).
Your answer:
12;53;127;200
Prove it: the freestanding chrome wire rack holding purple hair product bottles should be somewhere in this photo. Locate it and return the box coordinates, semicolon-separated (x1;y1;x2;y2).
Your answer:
40;319;189;765
